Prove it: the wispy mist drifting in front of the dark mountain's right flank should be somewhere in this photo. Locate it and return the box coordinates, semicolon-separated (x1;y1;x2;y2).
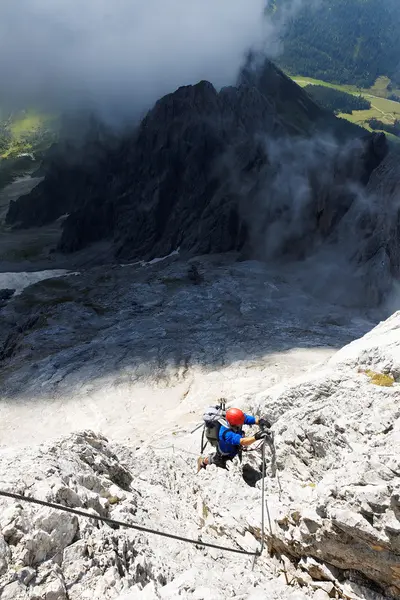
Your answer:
243;133;394;307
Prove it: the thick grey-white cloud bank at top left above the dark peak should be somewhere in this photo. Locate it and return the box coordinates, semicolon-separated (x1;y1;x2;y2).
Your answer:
0;0;268;118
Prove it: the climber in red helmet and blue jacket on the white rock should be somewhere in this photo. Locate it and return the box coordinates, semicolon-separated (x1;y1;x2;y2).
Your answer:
197;408;271;472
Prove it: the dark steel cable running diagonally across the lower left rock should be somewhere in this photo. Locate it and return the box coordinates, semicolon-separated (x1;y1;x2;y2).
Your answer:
0;490;261;557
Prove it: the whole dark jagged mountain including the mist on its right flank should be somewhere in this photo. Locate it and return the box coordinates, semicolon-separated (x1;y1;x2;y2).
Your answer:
7;56;398;304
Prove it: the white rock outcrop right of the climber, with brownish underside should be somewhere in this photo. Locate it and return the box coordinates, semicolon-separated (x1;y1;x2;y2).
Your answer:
252;313;400;598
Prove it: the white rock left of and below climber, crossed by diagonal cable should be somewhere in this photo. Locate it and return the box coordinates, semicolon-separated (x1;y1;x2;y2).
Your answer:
0;431;308;600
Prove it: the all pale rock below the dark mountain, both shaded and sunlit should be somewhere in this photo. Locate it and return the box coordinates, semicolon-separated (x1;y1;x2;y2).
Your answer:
0;257;400;600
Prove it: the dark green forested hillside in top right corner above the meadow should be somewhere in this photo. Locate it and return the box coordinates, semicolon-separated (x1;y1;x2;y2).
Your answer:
269;0;400;88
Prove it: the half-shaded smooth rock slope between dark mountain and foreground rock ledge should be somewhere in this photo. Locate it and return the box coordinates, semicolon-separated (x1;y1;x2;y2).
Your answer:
0;255;378;444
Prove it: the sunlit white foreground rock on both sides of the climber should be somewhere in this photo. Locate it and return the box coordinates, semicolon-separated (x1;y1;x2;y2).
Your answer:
0;300;400;600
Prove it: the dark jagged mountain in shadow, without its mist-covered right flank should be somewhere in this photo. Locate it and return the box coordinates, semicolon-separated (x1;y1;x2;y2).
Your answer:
3;61;387;272
